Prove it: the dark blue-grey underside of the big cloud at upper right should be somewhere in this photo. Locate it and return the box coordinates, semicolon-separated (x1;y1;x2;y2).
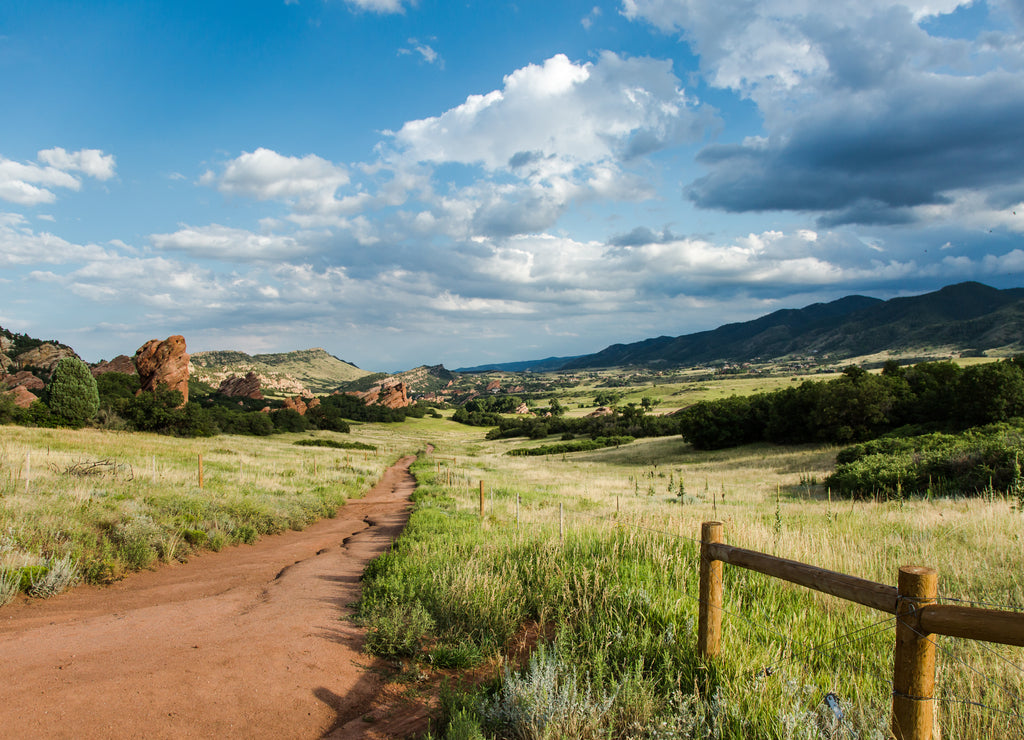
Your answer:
686;73;1024;224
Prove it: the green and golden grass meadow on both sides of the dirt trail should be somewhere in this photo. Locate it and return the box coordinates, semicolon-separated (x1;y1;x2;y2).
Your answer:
0;419;1024;738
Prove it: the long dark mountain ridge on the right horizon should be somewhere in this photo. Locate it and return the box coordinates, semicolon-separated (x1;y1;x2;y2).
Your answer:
563;282;1024;369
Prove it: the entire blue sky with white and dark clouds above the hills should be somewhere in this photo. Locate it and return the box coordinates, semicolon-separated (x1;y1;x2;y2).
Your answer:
0;0;1024;372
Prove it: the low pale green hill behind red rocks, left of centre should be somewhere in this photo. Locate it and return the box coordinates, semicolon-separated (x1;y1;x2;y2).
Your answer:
191;347;370;395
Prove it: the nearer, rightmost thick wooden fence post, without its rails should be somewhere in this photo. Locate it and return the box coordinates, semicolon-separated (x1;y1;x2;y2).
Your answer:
892;565;939;740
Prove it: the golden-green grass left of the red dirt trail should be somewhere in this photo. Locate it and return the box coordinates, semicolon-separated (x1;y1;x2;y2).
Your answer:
0;427;399;596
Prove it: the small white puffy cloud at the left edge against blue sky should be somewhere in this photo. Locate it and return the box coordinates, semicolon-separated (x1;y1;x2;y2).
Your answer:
0;147;115;206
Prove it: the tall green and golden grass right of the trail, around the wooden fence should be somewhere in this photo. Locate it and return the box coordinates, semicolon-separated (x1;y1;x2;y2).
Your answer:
362;437;1024;738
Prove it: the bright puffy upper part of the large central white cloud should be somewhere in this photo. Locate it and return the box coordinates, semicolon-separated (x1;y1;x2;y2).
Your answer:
394;52;710;176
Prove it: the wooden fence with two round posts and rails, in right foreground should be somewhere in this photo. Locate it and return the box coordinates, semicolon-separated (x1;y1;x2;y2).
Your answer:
697;522;1024;740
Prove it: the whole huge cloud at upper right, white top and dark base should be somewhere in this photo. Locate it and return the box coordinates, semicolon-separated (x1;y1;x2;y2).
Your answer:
623;0;1024;227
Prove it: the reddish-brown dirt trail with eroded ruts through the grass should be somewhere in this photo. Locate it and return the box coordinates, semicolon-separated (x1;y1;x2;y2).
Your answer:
0;456;415;738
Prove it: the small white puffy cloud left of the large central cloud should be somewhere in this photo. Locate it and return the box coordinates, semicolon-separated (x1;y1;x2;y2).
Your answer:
200;147;349;212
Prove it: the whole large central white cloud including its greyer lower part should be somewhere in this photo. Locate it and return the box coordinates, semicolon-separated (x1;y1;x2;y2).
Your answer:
374;52;717;237
